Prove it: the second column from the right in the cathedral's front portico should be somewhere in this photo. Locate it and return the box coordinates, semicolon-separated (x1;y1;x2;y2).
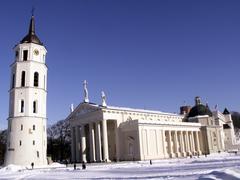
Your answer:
95;122;102;162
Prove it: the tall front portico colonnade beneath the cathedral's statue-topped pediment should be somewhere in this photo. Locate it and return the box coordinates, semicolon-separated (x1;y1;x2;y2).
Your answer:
71;120;109;162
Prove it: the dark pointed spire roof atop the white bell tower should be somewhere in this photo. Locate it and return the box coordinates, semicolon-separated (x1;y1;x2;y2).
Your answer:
20;16;43;45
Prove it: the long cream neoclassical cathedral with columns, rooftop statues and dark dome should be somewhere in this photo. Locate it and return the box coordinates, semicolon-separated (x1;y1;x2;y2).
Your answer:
67;81;235;162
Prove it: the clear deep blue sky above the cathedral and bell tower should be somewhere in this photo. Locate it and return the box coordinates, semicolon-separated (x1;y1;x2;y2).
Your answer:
0;0;240;129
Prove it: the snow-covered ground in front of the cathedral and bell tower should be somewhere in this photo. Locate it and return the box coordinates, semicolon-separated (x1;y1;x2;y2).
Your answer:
0;153;240;180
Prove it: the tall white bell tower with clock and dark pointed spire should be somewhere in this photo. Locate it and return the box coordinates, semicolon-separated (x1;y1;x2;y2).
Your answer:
5;16;47;166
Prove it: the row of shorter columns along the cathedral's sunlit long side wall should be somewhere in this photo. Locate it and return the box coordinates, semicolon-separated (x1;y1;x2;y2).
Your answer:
165;130;202;158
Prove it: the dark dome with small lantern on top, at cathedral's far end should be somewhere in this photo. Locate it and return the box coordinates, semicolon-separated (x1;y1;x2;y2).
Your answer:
188;96;212;117
